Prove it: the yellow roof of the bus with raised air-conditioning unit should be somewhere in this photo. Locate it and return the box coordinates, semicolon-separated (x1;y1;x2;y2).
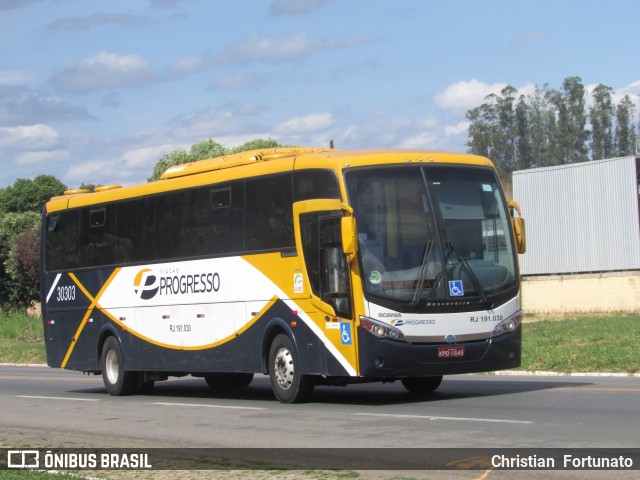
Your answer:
46;147;493;213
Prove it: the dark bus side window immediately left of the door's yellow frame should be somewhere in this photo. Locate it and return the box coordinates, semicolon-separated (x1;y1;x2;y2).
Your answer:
245;174;295;251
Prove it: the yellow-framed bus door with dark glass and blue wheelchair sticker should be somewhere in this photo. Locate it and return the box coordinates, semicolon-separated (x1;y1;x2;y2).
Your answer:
293;199;357;373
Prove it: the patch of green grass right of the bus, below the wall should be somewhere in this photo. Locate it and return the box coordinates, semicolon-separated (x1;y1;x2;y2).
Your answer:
521;313;640;373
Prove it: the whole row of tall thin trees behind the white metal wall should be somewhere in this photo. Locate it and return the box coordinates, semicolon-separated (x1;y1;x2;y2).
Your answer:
467;77;640;169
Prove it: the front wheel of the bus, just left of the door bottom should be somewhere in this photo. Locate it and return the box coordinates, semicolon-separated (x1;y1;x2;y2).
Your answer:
269;334;315;403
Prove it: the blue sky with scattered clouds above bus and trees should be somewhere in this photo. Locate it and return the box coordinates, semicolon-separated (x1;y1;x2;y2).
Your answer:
0;0;640;188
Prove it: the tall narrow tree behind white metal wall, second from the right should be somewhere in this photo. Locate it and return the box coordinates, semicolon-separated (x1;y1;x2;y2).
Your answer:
589;83;614;160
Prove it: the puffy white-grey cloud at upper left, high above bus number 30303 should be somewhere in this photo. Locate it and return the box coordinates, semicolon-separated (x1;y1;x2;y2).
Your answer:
51;52;158;94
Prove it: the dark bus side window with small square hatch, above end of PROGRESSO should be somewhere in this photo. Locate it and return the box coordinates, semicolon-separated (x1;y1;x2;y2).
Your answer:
197;182;244;255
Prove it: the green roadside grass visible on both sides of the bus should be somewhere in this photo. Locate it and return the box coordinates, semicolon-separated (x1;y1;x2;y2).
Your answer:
0;312;640;373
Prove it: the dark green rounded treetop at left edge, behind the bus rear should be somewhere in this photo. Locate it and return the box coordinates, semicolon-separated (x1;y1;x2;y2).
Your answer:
0;175;67;213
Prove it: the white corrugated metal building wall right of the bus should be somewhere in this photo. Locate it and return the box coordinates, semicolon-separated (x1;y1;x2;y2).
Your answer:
512;157;640;275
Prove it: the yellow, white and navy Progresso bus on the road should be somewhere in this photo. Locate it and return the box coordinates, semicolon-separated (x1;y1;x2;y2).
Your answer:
41;148;526;403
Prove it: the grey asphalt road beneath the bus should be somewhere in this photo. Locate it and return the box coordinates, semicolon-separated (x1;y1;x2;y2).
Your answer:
0;366;640;478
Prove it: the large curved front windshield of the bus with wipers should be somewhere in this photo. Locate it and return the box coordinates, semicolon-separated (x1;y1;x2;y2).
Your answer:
345;165;517;307
